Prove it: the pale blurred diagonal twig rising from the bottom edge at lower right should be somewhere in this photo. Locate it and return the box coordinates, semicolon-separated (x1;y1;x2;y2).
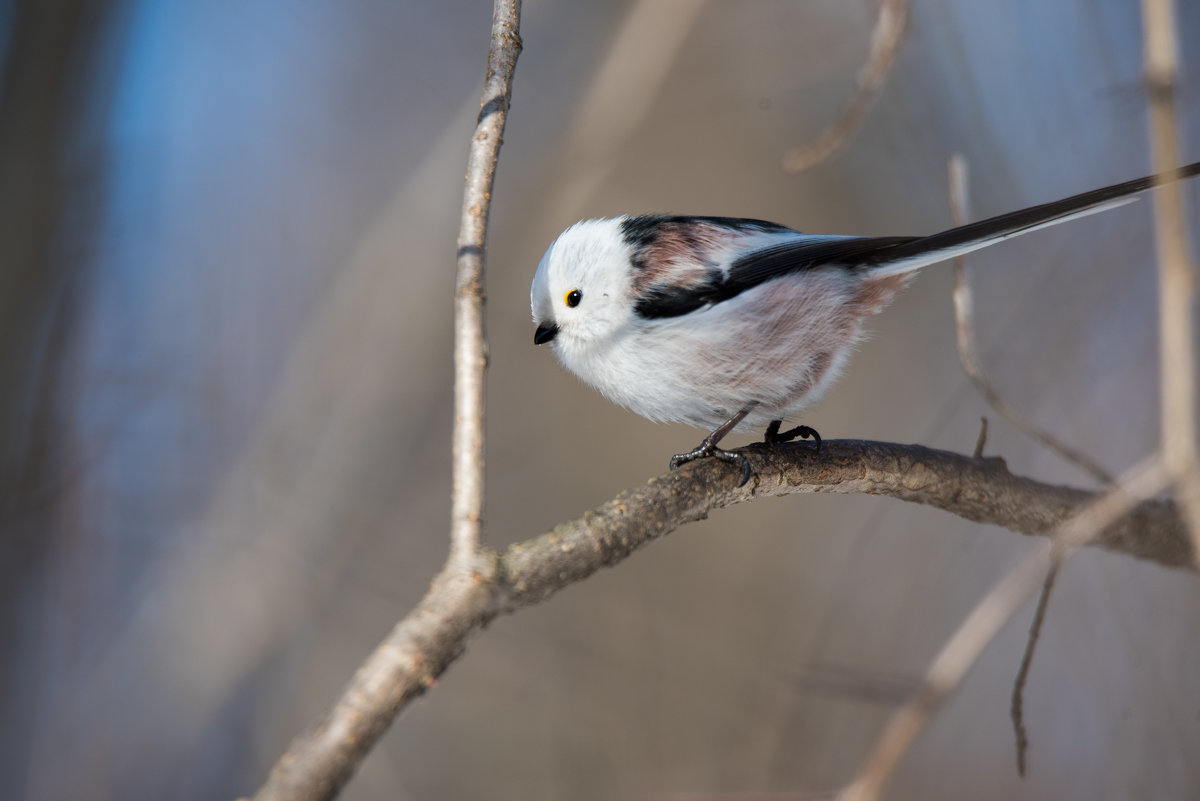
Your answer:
839;454;1169;801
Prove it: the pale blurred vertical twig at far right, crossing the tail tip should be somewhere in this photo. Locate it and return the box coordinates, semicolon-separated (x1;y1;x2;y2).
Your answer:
1141;0;1200;568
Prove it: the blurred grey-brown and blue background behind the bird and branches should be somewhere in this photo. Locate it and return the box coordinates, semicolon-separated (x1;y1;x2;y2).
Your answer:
0;0;1200;801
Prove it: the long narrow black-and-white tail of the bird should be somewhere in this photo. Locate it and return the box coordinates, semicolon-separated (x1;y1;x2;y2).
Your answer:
871;162;1200;277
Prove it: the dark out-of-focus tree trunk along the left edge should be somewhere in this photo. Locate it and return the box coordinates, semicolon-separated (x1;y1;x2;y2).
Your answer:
0;0;124;787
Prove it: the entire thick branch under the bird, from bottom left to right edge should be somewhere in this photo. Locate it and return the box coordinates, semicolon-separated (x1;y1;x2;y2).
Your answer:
257;440;1194;799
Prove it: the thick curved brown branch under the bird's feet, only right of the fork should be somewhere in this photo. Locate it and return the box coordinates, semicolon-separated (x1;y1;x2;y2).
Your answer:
500;440;1193;610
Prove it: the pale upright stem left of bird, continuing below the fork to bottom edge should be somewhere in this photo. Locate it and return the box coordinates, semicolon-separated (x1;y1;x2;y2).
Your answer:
254;0;521;801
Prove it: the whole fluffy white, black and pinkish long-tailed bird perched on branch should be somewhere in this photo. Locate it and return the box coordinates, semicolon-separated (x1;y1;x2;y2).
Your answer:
529;162;1200;483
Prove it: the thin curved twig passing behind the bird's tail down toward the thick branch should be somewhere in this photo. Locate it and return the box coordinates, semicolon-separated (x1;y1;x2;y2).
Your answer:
949;153;1112;484
